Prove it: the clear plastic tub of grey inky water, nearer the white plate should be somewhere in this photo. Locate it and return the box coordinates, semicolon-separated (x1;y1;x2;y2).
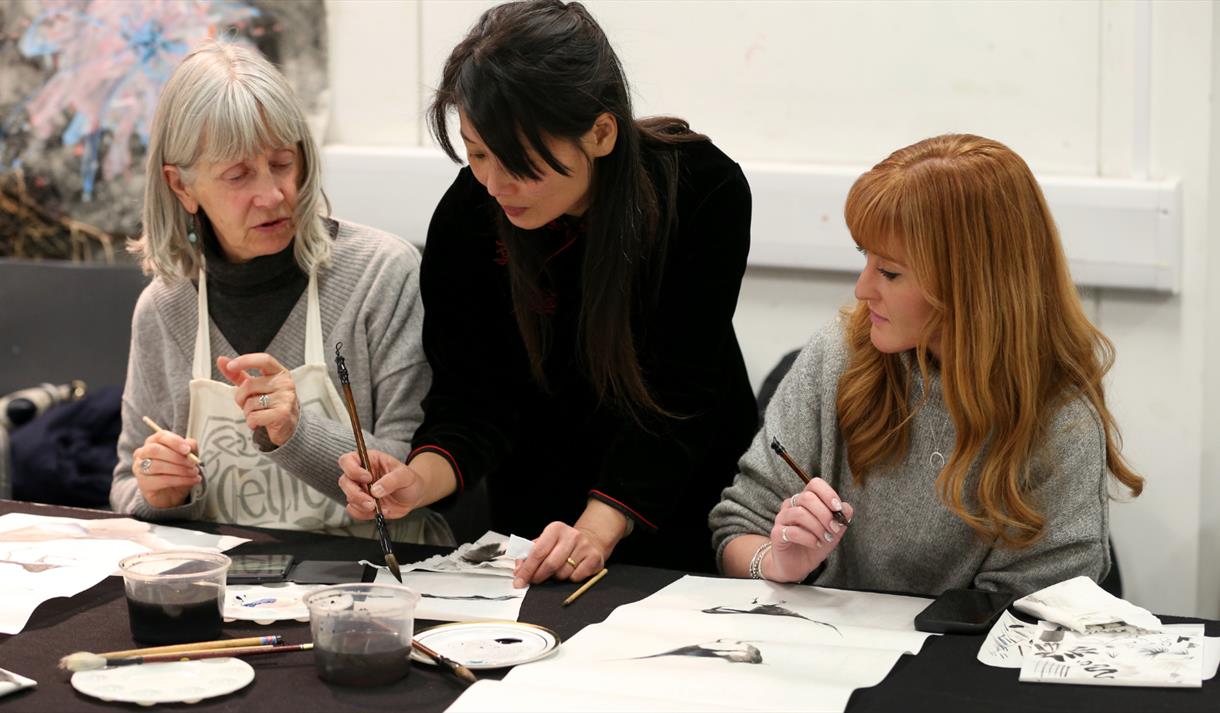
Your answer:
305;584;420;686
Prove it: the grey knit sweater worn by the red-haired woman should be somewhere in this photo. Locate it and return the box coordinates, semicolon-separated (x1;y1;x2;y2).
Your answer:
709;321;1110;596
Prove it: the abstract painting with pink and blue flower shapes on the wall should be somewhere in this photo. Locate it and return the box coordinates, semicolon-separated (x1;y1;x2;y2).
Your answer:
0;0;328;262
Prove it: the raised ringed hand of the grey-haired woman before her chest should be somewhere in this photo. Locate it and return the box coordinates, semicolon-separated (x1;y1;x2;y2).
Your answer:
216;353;301;446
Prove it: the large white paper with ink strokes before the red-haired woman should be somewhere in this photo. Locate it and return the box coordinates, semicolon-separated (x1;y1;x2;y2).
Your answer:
450;576;928;712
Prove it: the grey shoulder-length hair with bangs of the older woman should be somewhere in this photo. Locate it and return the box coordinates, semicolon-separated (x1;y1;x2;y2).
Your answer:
128;40;331;281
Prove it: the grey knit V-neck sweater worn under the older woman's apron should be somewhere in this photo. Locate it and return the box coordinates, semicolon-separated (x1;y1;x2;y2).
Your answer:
110;222;453;545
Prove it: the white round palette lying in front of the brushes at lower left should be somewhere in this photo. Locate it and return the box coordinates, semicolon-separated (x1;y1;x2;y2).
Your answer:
72;658;254;706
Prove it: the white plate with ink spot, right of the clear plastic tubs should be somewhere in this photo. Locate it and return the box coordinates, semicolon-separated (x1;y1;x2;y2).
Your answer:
411;621;559;670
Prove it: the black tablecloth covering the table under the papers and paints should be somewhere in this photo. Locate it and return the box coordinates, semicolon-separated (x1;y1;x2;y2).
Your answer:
0;501;1220;713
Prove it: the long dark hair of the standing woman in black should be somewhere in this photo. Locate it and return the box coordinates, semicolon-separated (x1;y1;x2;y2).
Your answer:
428;0;706;419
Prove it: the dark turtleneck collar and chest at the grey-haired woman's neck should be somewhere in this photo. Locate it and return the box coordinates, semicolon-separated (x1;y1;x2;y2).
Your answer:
200;221;309;354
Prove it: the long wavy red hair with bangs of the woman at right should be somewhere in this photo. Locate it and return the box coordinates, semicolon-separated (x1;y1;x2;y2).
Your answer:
837;134;1143;547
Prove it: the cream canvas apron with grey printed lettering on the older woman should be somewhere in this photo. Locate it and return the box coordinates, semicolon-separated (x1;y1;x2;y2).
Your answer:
187;270;429;542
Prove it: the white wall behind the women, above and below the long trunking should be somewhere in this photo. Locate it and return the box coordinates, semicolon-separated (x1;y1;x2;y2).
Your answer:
327;0;1220;618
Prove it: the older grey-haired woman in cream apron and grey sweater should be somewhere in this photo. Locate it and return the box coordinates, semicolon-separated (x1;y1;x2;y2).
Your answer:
110;42;453;545
